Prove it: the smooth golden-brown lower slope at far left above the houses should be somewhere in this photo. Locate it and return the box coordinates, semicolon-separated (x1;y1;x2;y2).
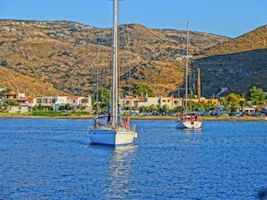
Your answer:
0;67;66;97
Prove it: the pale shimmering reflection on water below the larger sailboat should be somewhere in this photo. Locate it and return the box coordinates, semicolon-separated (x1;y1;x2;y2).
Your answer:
106;145;137;199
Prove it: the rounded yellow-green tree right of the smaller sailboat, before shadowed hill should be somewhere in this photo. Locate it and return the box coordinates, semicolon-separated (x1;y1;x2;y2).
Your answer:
221;93;241;112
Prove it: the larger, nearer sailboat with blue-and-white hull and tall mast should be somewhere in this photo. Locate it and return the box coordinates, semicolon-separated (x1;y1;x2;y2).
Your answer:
89;0;137;146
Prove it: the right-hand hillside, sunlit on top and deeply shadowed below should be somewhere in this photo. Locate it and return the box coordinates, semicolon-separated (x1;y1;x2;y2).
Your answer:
194;25;267;96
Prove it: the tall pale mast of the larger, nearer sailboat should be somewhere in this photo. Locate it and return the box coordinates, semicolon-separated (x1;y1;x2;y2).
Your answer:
111;0;118;126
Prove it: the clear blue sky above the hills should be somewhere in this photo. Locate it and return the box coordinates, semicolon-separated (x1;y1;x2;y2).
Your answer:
0;0;267;37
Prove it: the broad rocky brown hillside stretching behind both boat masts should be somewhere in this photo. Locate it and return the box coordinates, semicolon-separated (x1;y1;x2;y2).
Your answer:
0;20;228;95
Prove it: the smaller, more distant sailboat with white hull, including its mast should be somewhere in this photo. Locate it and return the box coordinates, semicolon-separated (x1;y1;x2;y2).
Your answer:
177;23;203;129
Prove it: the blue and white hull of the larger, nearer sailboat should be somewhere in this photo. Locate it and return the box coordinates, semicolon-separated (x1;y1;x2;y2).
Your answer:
89;128;137;146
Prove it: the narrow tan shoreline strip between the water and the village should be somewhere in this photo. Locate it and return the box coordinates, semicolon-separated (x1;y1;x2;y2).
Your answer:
0;113;267;122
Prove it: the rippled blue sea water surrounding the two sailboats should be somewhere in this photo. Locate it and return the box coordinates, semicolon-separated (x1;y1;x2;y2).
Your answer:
0;119;267;200
